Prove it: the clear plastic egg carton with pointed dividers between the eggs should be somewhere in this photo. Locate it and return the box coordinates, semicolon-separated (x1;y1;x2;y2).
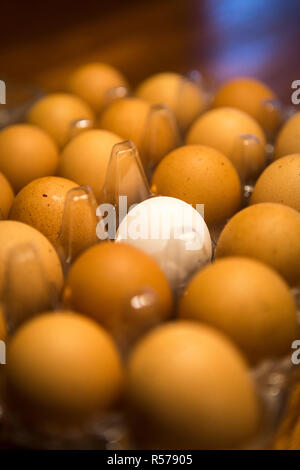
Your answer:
0;71;300;449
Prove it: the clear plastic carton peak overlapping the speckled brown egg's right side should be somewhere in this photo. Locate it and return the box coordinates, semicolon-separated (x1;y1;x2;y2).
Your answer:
55;186;101;272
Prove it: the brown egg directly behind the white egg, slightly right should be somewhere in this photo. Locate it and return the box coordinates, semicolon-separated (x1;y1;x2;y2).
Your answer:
152;145;241;227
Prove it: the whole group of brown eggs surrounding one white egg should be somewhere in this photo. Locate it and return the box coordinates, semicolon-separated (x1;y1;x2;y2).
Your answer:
0;63;300;449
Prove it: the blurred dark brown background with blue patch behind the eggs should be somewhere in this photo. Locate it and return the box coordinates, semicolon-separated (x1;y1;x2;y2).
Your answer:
0;0;300;102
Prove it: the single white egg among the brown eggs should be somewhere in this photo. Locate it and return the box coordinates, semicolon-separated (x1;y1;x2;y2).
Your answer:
116;196;212;290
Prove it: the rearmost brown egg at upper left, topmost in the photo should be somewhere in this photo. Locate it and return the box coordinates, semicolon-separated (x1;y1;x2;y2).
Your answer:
67;62;128;112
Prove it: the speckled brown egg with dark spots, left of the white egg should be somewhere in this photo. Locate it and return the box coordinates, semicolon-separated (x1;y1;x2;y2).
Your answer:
9;176;77;243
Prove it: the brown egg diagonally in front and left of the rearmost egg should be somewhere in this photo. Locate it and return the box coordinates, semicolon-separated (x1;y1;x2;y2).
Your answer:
27;93;94;147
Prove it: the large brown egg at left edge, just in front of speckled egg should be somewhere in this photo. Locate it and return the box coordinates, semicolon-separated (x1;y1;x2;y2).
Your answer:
0;220;63;312
